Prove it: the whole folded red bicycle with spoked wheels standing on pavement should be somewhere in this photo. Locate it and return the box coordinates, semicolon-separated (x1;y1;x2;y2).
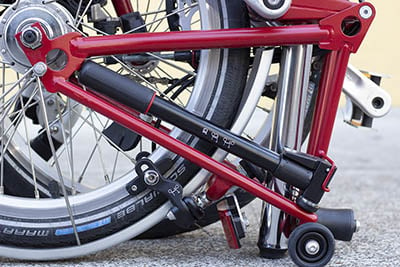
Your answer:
0;0;391;266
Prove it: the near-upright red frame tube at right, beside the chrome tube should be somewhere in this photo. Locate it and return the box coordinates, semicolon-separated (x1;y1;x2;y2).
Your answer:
307;45;351;156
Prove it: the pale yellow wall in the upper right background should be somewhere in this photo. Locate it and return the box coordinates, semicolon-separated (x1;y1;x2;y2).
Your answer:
351;0;400;106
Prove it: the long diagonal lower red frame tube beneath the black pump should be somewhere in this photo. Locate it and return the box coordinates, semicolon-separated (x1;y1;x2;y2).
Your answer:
50;79;317;222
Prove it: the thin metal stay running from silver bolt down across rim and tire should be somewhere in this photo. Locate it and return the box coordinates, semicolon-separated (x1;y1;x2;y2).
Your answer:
37;78;81;246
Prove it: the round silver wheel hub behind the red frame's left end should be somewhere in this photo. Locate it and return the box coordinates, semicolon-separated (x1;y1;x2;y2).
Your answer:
0;0;74;73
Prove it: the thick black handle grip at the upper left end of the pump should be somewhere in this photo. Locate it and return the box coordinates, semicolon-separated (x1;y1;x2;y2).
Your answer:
78;61;155;113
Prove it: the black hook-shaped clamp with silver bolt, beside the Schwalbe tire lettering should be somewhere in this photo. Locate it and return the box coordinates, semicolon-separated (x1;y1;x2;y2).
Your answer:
133;158;204;228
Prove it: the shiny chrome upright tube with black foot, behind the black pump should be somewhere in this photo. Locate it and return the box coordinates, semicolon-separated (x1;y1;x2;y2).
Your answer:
258;45;312;258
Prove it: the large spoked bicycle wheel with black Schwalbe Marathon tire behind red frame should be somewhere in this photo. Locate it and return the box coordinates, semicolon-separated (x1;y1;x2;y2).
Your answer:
0;0;249;260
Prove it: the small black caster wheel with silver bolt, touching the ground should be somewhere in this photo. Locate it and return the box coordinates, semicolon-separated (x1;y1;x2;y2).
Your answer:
288;223;335;267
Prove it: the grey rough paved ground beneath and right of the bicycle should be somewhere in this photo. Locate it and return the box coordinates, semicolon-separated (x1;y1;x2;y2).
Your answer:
0;109;400;267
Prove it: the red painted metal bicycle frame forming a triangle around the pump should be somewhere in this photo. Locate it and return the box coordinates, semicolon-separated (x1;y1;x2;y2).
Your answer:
17;0;375;223
